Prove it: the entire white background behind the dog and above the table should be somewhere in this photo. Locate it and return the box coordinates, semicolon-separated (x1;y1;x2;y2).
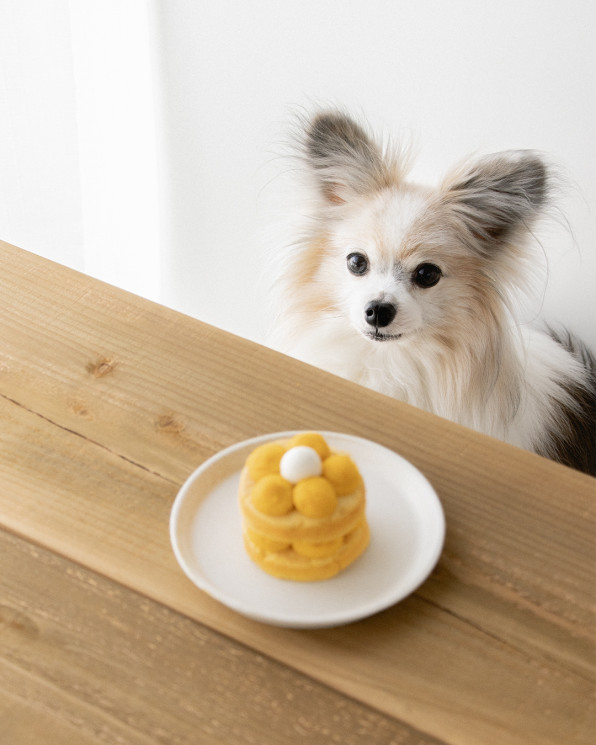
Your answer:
0;0;596;350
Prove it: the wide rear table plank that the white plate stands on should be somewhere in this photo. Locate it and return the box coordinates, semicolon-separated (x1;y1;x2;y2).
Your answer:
0;240;596;745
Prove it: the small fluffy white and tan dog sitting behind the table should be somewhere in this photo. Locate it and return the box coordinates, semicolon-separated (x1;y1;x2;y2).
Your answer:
272;111;596;474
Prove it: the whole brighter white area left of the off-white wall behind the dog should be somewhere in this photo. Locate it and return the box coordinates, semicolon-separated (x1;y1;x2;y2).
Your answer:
0;0;161;300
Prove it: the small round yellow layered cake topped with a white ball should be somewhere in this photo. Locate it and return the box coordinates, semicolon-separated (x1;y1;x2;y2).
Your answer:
239;432;370;581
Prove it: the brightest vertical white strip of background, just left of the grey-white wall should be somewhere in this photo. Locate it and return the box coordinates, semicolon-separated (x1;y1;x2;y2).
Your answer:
68;0;161;300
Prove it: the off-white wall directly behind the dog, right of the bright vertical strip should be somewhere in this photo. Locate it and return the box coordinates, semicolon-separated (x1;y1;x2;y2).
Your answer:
154;0;596;349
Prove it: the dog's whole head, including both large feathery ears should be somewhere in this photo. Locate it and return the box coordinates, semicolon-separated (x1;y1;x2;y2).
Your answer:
307;114;545;344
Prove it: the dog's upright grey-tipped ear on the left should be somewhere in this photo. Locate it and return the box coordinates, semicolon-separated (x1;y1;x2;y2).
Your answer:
304;111;395;204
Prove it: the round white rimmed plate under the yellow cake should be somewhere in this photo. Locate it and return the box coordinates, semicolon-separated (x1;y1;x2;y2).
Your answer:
170;432;445;628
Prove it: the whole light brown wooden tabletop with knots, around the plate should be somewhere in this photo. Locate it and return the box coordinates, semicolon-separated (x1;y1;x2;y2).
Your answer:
0;244;596;745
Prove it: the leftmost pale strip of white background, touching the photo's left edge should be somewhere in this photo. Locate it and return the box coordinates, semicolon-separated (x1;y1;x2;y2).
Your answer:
0;0;83;269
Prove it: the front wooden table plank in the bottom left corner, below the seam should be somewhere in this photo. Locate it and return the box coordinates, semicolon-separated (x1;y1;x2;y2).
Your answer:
0;531;440;745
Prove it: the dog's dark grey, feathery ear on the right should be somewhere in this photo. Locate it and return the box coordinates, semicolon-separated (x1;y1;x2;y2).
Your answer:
444;150;549;249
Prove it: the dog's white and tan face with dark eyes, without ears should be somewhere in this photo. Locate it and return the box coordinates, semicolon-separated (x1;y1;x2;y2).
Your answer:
322;189;468;342
